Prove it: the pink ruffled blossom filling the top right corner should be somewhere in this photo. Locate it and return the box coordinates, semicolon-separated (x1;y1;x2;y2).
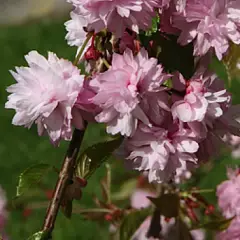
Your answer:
173;0;240;60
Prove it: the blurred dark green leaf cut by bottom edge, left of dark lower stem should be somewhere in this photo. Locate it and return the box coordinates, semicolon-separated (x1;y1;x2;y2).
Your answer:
119;208;152;240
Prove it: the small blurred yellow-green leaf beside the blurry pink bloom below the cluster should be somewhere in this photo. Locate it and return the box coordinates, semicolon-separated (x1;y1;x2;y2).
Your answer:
112;178;137;201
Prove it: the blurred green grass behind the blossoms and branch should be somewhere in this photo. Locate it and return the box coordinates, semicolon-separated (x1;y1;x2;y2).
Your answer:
0;12;240;240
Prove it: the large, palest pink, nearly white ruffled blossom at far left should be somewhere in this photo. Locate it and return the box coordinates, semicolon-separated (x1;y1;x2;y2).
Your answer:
5;51;84;145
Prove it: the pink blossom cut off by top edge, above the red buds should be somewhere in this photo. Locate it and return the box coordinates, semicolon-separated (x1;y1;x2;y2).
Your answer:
68;0;160;37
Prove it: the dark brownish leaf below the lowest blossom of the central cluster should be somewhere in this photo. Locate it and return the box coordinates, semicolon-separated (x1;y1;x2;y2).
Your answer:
148;193;180;218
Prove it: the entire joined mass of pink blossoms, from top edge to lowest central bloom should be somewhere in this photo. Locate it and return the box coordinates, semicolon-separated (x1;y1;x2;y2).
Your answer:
6;0;240;186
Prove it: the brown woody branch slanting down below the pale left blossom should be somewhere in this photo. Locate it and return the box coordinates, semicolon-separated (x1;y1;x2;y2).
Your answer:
43;129;84;238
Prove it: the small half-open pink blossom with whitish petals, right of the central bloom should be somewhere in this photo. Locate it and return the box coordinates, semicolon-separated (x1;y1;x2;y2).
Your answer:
172;71;229;122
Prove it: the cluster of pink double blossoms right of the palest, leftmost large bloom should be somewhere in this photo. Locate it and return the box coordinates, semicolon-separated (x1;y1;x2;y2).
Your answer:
95;49;239;182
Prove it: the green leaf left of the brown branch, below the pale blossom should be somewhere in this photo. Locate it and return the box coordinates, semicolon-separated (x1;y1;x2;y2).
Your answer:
17;163;53;197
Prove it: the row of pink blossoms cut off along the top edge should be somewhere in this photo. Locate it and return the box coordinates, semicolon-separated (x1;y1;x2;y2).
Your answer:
66;0;240;59
